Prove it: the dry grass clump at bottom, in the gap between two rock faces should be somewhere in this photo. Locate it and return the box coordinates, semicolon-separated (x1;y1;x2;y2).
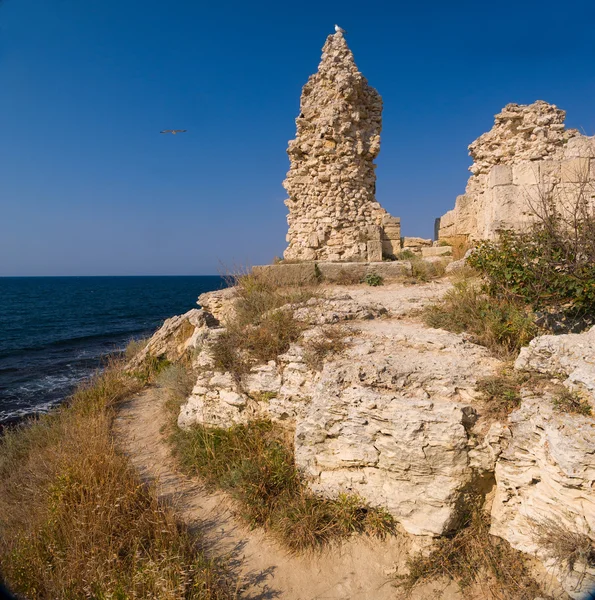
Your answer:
402;498;542;600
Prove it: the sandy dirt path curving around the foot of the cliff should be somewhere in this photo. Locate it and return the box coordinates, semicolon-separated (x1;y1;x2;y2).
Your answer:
115;388;462;600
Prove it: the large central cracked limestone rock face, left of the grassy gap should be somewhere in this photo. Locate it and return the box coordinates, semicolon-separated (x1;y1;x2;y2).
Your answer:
295;321;498;536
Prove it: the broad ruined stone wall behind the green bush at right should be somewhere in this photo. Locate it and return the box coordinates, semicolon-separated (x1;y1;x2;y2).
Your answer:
439;100;595;241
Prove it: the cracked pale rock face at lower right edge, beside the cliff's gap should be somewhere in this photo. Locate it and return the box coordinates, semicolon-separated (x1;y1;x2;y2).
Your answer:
491;396;595;600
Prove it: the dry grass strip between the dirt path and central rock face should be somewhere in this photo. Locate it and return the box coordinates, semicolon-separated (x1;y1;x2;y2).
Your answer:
171;421;394;552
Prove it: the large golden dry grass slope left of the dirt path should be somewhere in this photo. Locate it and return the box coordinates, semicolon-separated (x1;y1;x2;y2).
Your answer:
0;364;230;600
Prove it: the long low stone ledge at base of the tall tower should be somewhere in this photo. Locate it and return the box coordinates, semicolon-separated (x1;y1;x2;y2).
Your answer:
253;260;412;285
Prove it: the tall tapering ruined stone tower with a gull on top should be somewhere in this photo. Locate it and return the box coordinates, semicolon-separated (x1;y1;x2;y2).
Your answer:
283;32;401;261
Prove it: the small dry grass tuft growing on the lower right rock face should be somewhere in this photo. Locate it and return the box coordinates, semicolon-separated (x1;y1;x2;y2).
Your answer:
532;519;595;571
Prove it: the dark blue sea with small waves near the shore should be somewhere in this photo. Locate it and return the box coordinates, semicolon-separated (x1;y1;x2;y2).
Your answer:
0;276;225;424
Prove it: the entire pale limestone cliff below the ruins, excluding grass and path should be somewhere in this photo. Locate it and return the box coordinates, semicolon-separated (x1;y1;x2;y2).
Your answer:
140;281;595;599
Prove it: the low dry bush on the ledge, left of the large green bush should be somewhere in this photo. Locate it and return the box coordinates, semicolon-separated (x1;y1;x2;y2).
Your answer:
423;281;538;358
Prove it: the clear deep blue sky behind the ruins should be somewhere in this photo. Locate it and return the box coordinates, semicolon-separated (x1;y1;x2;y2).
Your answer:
0;0;595;276
